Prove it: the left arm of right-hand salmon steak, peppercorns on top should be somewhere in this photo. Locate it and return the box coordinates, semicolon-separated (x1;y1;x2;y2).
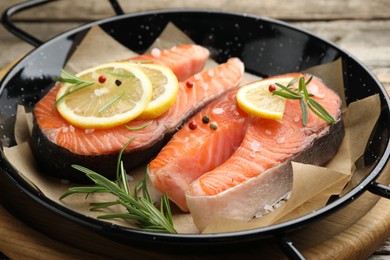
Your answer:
148;89;249;211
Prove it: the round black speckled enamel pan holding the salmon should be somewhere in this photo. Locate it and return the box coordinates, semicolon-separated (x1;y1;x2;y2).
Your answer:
0;1;390;257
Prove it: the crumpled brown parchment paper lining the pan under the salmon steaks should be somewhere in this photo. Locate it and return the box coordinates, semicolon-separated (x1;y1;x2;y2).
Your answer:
4;24;380;233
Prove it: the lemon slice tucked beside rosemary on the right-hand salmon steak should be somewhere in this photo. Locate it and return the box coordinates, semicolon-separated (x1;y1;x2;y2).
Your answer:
236;78;293;120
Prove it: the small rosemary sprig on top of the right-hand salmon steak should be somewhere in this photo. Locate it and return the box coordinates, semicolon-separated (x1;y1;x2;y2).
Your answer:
272;76;336;126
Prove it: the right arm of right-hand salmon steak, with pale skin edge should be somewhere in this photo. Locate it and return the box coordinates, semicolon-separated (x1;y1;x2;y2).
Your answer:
186;74;344;230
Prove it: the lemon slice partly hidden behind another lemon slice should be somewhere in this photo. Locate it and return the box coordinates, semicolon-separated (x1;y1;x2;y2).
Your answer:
132;64;179;119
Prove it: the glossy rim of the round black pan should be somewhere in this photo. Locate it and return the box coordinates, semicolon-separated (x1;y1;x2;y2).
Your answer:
0;9;390;246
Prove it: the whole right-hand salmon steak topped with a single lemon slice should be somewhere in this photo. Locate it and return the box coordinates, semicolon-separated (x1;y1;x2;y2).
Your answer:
149;73;344;230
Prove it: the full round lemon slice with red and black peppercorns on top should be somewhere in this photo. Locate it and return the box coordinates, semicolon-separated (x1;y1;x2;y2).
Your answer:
57;62;152;128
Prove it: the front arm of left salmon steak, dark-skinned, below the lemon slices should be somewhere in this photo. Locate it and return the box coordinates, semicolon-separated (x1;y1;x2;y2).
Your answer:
31;45;244;183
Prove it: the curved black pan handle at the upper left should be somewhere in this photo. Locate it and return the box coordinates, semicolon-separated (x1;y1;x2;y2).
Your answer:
2;0;124;47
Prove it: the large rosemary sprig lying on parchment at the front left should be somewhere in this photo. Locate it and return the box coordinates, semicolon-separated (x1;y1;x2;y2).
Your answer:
60;138;177;233
